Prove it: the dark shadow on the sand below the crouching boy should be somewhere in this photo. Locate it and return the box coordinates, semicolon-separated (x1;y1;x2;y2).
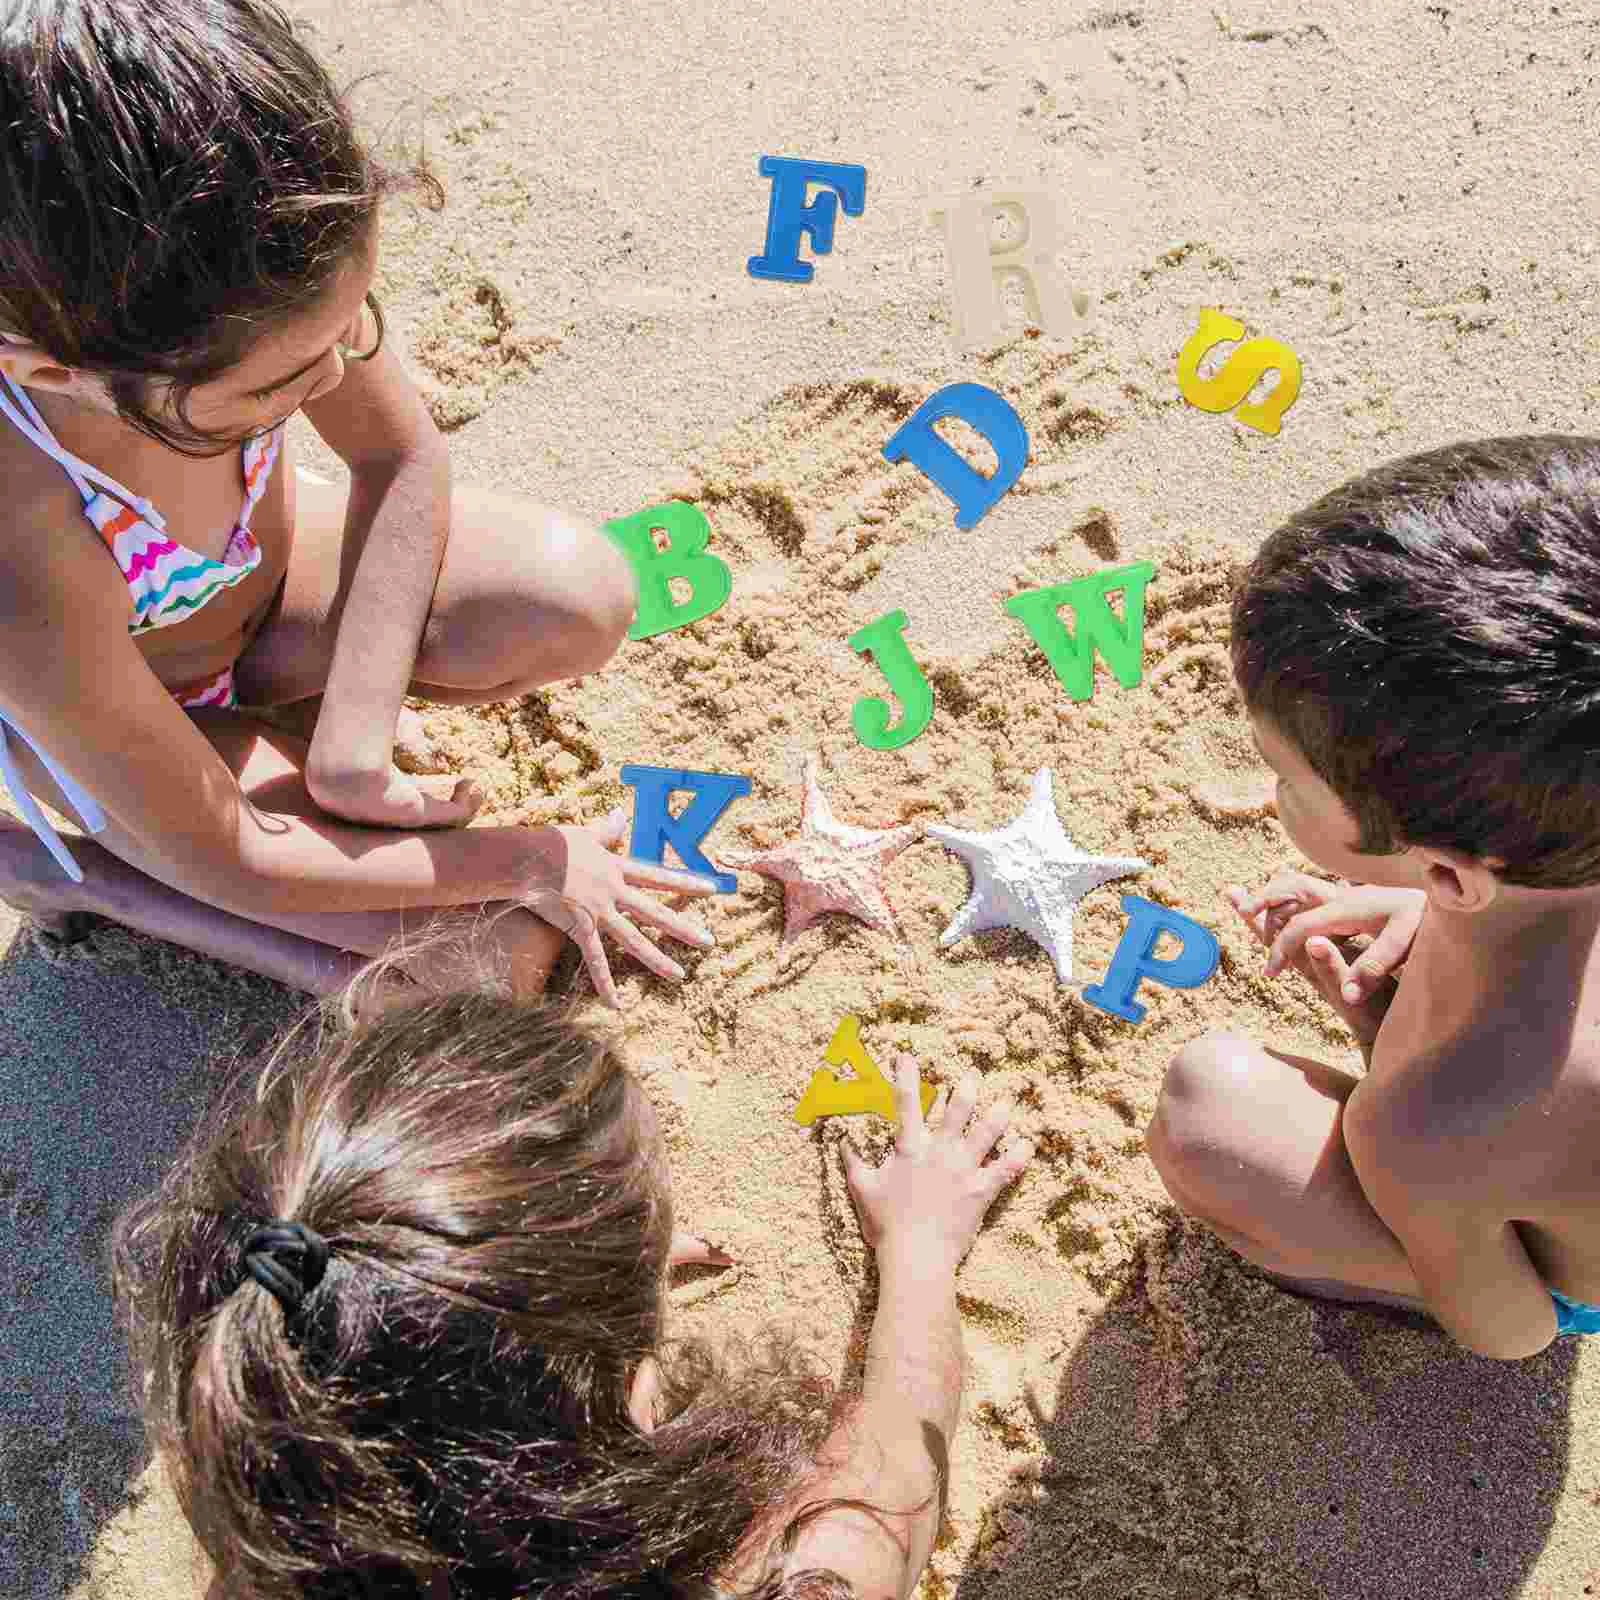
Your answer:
955;1218;1578;1600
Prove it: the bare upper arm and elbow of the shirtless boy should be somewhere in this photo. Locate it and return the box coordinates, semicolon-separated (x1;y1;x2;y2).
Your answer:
1344;1094;1555;1362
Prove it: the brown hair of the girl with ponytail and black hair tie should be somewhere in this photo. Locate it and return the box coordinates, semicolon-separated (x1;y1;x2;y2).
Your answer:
112;953;889;1600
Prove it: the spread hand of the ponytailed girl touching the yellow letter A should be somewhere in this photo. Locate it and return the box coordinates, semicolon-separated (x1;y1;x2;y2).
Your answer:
845;1056;1034;1277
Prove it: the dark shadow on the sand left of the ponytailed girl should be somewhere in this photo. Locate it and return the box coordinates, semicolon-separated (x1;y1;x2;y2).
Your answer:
0;928;306;1600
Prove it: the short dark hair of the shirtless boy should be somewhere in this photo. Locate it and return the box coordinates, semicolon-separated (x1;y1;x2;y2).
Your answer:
1232;434;1600;888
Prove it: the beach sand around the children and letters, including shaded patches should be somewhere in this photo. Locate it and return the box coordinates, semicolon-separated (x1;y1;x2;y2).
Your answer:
9;0;1600;1600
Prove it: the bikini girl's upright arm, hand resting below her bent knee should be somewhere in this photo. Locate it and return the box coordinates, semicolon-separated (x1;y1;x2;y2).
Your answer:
306;320;457;827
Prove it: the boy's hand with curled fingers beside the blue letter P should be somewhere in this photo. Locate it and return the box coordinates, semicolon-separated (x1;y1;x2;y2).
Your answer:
1226;869;1427;1043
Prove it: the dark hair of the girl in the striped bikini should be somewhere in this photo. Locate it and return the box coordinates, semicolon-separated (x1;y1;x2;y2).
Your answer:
0;0;443;456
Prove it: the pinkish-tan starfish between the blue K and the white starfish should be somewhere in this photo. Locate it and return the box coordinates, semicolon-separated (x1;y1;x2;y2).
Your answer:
723;755;922;941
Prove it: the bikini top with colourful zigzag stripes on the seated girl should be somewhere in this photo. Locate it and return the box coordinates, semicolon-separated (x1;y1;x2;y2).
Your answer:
0;373;285;634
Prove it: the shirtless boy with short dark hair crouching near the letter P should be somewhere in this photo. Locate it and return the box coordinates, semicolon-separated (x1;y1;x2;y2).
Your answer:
1149;435;1600;1358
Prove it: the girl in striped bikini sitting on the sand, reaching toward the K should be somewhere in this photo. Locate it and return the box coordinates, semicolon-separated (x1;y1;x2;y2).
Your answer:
0;0;712;998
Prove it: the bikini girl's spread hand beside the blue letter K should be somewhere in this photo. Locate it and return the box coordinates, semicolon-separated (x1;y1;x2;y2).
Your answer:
522;806;717;1010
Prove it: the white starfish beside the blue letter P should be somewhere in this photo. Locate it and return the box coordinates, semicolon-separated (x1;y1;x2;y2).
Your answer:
928;766;1149;982
